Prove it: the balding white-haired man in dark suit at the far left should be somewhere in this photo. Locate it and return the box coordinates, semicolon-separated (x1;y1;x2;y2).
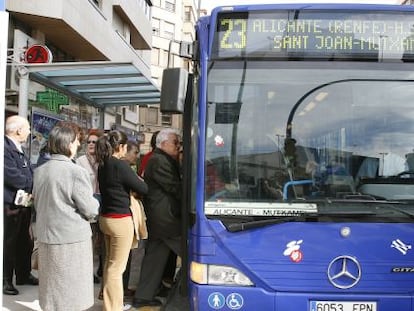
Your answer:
3;116;38;295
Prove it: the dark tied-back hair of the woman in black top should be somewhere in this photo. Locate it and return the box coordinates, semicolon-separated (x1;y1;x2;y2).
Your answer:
95;130;128;165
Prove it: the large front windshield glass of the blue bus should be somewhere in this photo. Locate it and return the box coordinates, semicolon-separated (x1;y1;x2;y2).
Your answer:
205;60;414;214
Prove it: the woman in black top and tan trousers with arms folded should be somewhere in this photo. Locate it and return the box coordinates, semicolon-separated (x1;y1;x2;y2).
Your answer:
95;131;148;311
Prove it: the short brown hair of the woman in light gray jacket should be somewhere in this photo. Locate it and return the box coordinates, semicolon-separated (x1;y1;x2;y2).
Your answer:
47;125;78;157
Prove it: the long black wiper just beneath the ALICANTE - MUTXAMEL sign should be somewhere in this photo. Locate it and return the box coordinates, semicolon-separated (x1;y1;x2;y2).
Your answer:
226;211;377;232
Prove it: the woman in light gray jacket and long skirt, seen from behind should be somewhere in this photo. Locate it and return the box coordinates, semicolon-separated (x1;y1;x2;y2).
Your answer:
33;123;99;311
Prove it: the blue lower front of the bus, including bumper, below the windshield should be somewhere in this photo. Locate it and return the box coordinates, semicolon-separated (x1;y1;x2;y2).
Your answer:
191;220;414;311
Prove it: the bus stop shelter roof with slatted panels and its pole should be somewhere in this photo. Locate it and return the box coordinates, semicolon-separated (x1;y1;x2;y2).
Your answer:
17;61;160;125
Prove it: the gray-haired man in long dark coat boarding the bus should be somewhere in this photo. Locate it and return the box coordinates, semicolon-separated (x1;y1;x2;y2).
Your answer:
132;129;182;308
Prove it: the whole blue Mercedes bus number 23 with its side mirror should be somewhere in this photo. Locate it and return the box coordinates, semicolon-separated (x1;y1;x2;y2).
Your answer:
161;4;414;311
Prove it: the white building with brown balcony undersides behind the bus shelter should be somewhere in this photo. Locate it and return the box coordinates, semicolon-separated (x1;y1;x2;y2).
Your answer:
6;0;156;146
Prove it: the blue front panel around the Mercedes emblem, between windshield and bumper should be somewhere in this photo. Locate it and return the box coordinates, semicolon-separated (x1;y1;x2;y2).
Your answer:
196;221;414;294
